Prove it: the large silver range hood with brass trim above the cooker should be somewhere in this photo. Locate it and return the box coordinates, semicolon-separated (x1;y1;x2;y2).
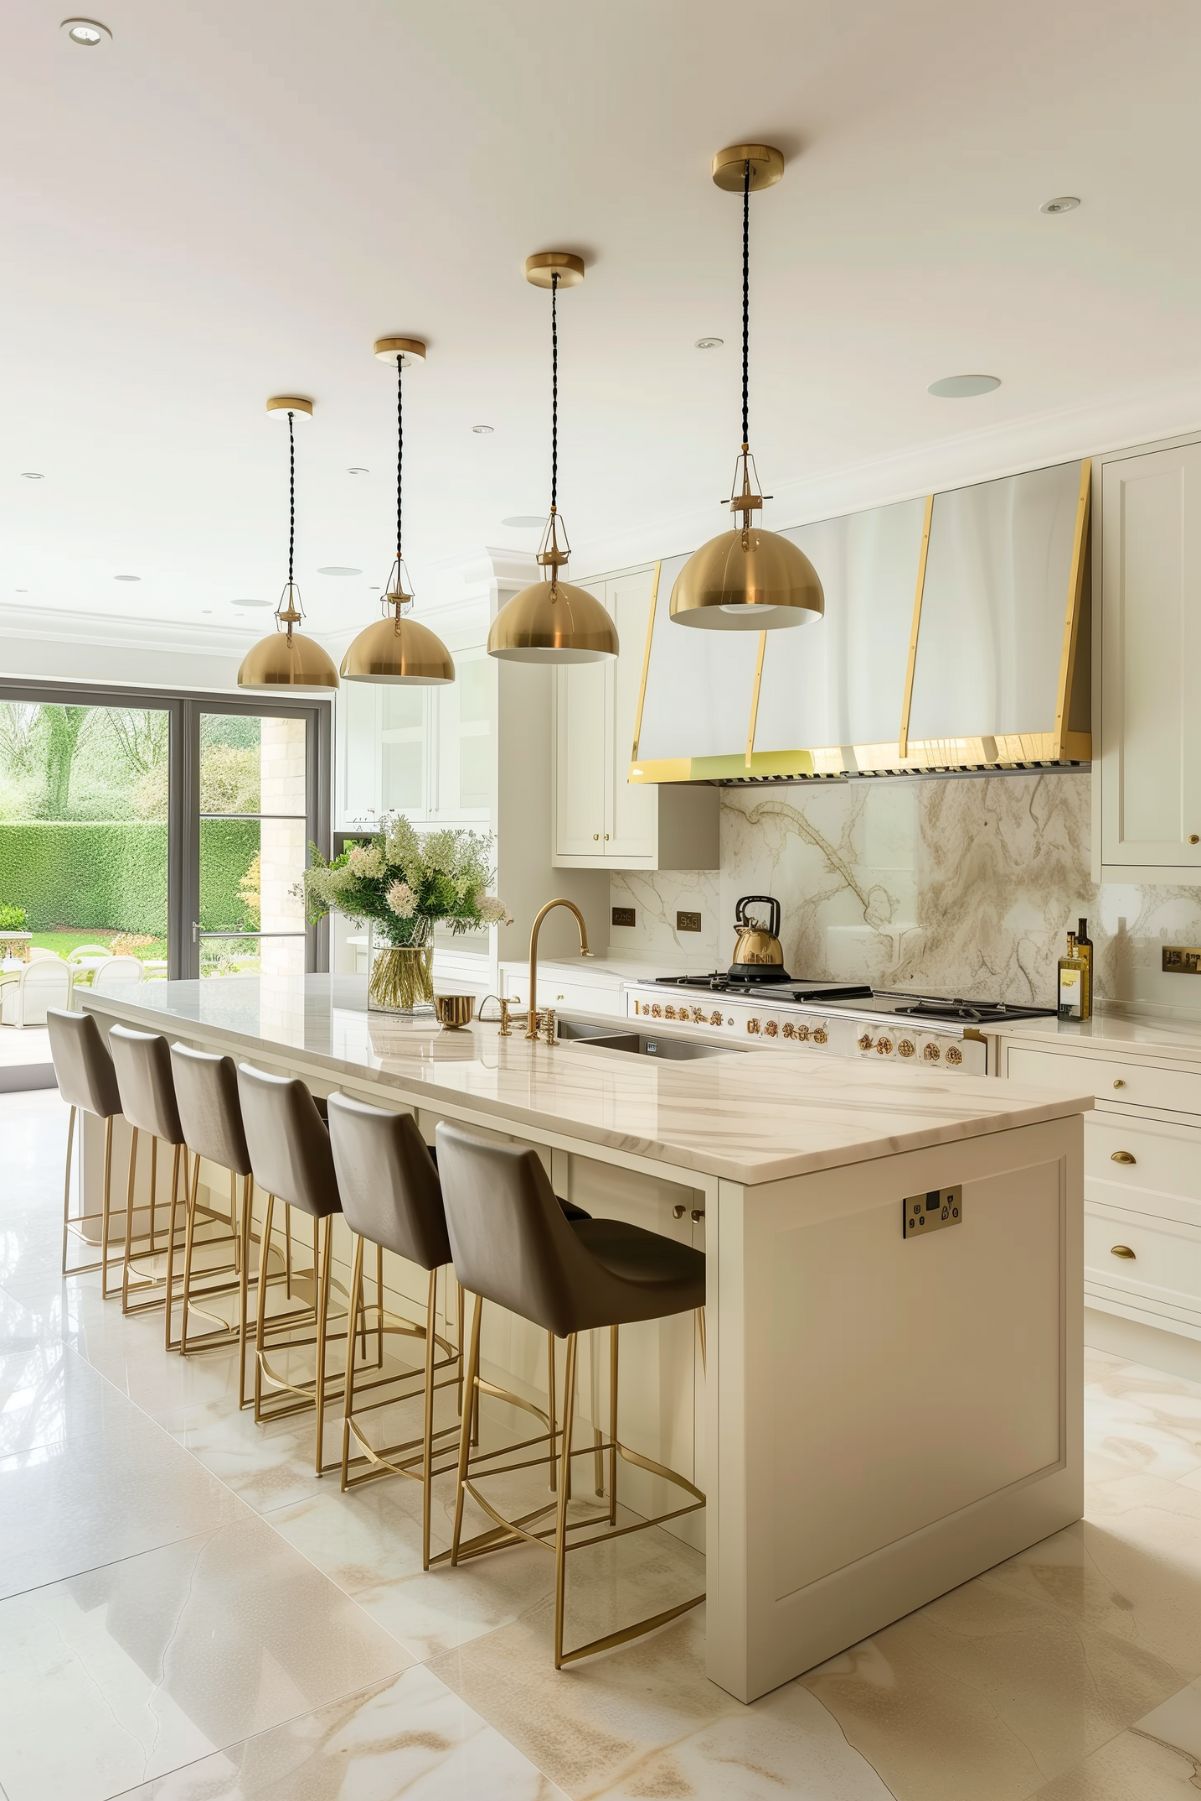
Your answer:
628;461;1091;783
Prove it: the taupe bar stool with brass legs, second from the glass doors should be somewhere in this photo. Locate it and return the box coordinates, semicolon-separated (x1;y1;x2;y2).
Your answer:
108;1025;187;1351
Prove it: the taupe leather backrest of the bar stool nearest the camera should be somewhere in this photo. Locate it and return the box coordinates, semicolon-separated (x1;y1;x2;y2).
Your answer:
436;1120;610;1338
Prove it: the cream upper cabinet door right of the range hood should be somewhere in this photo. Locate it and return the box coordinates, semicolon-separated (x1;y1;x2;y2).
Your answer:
1100;445;1201;879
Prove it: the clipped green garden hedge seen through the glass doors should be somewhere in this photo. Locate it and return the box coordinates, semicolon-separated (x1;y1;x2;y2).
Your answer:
0;819;259;938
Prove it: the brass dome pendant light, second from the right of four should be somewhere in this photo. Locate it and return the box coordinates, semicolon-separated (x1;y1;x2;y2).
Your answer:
488;250;618;663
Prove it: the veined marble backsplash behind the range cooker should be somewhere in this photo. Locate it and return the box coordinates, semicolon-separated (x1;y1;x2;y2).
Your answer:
610;771;1201;1012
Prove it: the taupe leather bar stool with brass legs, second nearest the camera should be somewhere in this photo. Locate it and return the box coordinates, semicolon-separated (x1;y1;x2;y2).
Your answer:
330;1095;463;1569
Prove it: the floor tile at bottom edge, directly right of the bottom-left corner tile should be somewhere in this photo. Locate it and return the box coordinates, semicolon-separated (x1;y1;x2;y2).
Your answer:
108;1670;562;1801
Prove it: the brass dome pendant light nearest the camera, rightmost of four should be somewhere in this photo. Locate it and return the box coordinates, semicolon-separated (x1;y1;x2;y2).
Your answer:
672;144;826;632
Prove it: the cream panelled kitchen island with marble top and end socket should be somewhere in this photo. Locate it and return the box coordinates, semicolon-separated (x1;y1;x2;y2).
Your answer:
81;976;1091;1700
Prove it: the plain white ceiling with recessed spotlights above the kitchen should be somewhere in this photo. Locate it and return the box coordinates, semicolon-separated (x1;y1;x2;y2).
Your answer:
0;0;1201;644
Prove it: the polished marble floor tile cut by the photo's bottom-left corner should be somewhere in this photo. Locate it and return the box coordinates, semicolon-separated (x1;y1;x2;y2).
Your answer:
0;1516;409;1801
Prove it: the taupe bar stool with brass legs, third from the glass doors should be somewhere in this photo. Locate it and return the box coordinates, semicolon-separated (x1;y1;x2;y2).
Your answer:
167;1045;282;1407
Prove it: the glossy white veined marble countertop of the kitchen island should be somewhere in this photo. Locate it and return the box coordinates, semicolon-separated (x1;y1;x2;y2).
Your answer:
81;976;1093;1183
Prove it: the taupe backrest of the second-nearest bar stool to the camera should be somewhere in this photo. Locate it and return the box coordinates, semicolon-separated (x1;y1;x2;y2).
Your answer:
330;1095;450;1270
